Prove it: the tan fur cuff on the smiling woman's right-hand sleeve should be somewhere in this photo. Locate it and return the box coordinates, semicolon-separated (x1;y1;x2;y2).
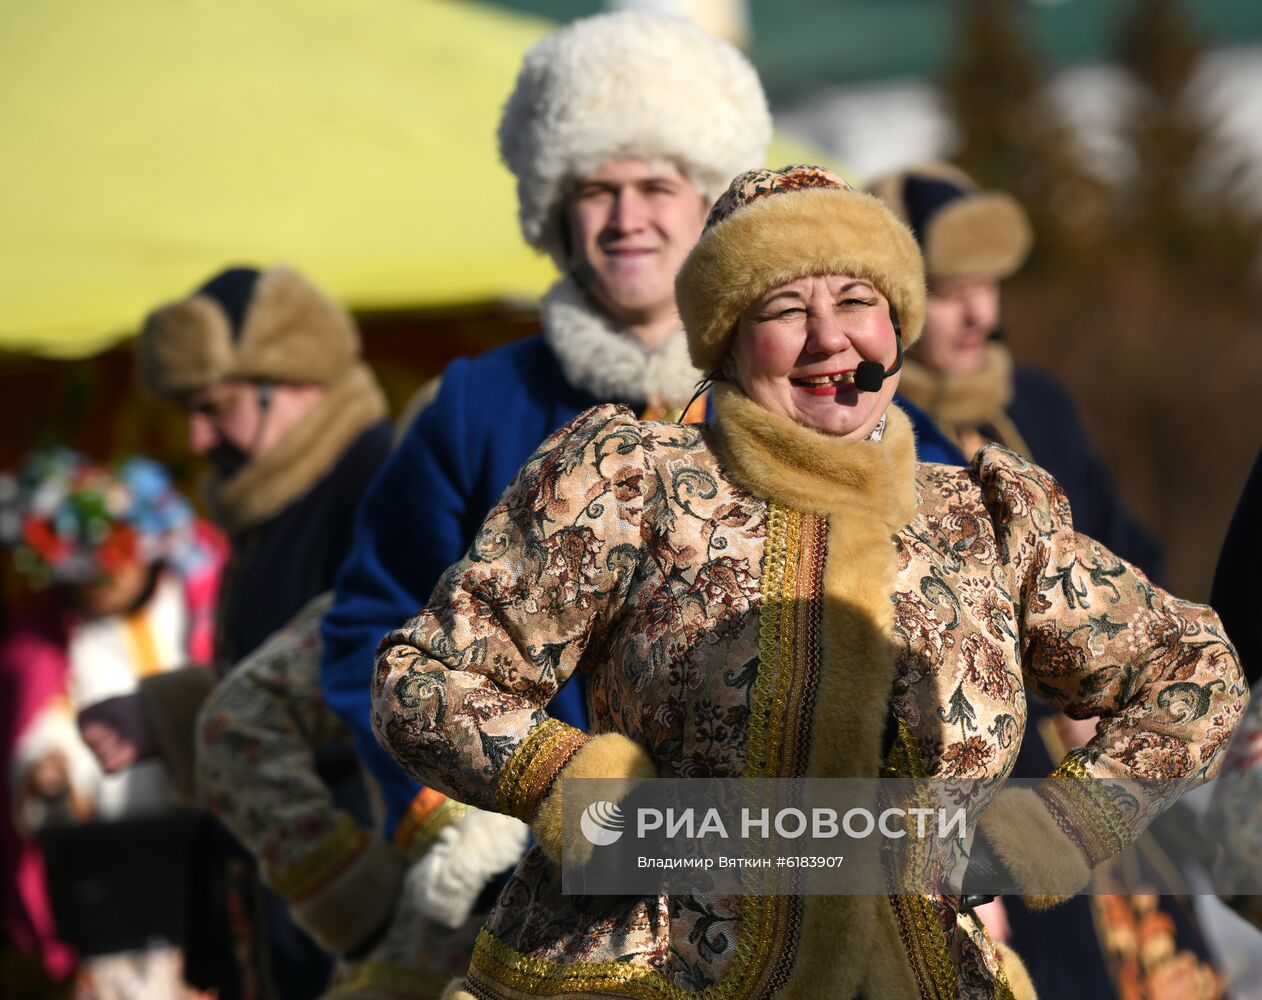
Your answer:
981;788;1092;909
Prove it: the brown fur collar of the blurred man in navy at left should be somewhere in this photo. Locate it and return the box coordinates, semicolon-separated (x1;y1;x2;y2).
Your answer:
207;361;386;534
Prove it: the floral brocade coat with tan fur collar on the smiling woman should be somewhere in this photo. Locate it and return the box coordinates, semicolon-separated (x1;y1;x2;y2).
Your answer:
374;386;1247;1000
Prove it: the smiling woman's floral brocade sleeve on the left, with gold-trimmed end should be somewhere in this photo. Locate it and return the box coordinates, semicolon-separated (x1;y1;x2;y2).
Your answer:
372;405;651;822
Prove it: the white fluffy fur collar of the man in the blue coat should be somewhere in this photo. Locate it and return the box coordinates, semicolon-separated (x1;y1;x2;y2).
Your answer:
543;278;702;408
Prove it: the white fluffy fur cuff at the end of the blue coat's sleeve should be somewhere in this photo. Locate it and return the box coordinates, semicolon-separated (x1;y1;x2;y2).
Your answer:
405;809;529;928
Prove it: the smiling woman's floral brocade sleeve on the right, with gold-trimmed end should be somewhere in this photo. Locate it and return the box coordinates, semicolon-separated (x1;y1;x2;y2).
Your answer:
974;447;1248;866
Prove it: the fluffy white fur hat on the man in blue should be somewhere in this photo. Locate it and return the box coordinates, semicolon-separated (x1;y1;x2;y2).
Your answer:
500;10;771;269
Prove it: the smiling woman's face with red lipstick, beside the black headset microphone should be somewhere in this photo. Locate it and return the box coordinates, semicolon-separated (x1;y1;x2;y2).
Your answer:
723;274;899;441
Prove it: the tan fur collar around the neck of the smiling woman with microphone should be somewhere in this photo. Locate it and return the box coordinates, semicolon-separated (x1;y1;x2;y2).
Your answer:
712;384;916;534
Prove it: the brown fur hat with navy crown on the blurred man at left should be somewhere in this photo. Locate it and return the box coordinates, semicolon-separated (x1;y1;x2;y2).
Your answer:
136;268;360;396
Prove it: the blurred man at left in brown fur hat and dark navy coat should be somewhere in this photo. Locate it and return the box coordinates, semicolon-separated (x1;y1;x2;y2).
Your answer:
83;268;391;997
